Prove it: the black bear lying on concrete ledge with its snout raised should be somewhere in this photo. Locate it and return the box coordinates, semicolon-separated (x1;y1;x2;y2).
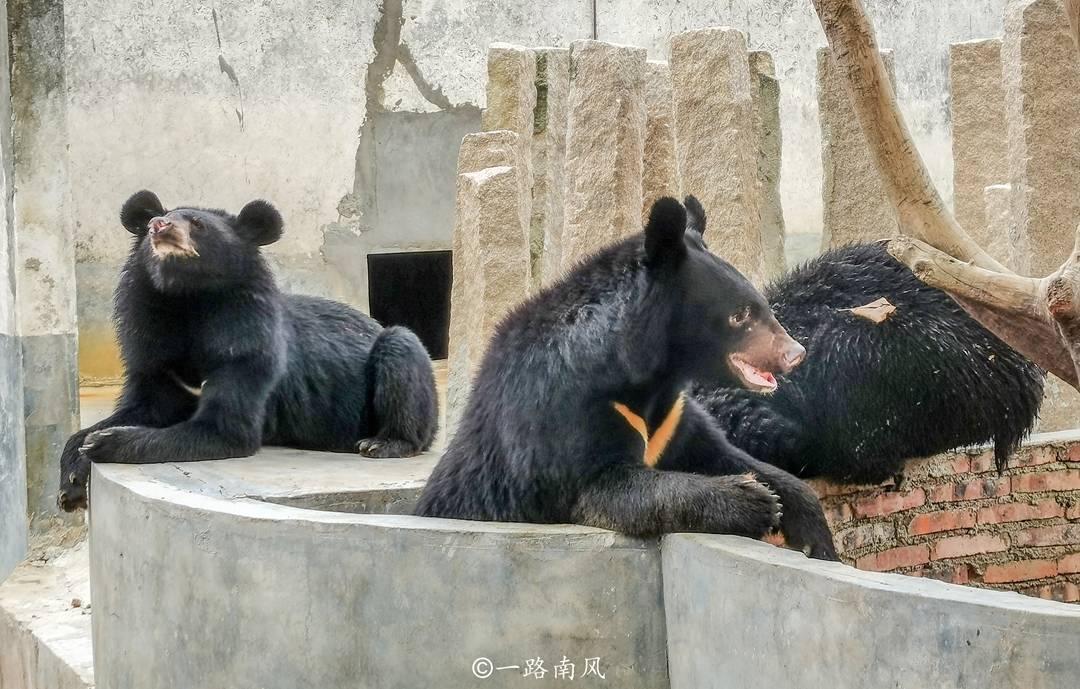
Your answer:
58;191;437;511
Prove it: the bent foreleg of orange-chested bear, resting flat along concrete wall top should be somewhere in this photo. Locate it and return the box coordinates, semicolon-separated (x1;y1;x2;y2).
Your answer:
572;465;780;538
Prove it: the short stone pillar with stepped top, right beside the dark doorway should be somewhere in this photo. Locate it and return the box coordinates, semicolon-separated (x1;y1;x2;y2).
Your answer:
445;131;531;433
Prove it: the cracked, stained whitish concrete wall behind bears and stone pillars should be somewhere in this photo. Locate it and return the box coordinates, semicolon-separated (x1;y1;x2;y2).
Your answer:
49;0;1003;378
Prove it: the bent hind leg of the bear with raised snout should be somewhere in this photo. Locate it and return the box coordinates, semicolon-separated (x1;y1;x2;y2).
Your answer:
356;326;438;457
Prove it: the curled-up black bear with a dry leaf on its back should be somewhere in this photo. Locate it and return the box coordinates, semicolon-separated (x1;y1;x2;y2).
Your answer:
696;243;1043;483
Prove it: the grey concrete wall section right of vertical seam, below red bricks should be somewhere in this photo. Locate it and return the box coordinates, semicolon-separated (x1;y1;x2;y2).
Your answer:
662;535;1080;689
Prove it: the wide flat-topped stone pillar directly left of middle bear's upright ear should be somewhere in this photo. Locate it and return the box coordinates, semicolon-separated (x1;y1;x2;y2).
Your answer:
561;40;646;270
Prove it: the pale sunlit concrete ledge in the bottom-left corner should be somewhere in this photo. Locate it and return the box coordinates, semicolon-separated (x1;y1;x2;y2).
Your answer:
0;539;93;689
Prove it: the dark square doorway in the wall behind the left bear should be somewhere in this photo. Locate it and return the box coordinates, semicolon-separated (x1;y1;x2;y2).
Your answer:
367;252;454;359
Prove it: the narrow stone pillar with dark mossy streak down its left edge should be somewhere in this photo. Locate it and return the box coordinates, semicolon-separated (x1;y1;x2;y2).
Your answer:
530;48;570;286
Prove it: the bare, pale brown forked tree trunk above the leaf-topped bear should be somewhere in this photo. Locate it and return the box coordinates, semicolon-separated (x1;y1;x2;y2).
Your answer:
813;0;1080;389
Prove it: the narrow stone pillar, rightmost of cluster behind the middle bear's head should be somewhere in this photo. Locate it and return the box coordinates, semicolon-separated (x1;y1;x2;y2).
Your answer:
750;51;787;280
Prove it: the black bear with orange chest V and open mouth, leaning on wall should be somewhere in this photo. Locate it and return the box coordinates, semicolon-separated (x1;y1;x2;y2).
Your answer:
417;198;836;559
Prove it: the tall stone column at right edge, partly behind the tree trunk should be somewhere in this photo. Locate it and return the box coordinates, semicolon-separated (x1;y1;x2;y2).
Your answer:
1001;0;1080;431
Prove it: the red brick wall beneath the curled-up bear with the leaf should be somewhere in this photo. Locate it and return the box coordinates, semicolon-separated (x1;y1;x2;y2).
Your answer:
810;441;1080;603
